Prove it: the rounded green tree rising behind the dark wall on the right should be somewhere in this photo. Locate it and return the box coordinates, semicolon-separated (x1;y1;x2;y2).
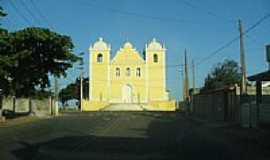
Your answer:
202;60;241;91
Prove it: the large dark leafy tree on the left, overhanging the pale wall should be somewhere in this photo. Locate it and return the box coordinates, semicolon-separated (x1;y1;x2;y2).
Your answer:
0;27;80;96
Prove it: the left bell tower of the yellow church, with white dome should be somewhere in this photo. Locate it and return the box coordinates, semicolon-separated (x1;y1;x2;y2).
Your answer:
89;38;111;102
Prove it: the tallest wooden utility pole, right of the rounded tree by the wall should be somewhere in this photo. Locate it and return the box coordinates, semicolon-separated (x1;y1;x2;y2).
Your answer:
238;19;247;95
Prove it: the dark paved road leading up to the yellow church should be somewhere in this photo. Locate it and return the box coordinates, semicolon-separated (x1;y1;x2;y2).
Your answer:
0;112;270;160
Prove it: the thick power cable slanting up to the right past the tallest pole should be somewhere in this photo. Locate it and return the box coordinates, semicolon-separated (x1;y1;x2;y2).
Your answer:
197;13;270;65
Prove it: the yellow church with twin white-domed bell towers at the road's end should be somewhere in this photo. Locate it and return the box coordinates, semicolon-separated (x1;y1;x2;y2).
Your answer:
82;38;175;111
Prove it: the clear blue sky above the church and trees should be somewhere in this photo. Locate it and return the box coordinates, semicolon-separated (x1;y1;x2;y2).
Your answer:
0;0;270;99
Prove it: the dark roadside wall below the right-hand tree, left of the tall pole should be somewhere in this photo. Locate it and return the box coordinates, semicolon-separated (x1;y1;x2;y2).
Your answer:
191;88;240;121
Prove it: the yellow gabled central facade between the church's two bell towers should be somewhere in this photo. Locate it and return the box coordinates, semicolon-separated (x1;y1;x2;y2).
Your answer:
110;46;147;103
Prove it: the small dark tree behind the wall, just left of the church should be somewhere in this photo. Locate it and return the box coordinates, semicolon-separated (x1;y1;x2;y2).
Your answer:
59;78;89;105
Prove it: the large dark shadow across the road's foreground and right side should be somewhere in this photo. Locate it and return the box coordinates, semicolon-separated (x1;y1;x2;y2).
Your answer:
8;112;251;160
